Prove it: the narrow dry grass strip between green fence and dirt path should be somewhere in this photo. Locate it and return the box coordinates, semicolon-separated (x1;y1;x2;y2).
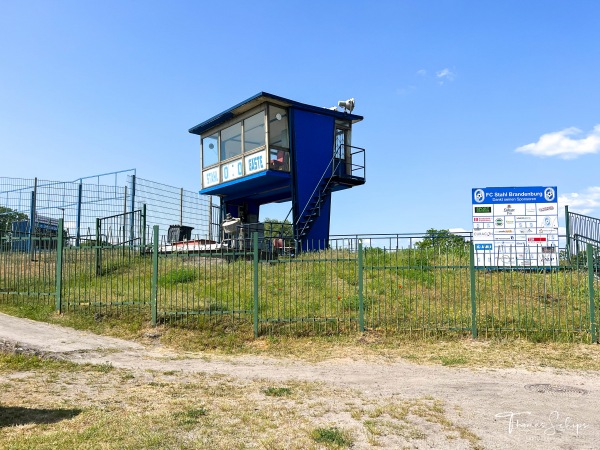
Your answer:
0;304;600;371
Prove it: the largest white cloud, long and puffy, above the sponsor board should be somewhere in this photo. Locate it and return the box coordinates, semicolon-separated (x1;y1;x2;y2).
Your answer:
515;125;600;159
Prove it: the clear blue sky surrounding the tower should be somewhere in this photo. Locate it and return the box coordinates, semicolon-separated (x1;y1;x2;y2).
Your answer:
0;0;600;234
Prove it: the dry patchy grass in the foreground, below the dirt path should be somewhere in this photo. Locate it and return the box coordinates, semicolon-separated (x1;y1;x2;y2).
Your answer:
0;354;478;450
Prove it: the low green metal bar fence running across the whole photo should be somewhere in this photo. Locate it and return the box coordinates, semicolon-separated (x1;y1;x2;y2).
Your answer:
0;227;600;342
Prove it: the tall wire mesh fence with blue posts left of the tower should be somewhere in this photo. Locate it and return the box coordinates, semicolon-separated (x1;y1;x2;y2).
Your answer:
0;171;221;251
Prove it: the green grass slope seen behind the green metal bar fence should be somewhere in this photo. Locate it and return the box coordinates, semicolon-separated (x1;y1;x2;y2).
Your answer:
0;244;600;346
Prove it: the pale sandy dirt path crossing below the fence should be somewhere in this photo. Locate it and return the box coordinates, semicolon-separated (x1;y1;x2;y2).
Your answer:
0;314;600;450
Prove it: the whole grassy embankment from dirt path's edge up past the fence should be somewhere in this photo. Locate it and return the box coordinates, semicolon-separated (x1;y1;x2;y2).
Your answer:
0;244;600;370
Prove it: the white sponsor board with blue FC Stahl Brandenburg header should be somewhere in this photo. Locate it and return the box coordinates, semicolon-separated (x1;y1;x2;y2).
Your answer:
471;186;558;267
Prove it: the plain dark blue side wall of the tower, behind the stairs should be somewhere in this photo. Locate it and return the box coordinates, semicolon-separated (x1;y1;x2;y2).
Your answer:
291;108;335;250
